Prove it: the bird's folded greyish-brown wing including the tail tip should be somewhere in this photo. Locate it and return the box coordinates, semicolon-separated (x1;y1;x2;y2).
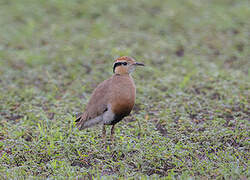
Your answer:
76;79;111;130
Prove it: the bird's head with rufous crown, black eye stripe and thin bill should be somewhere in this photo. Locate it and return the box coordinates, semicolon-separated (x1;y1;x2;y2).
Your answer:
113;56;144;74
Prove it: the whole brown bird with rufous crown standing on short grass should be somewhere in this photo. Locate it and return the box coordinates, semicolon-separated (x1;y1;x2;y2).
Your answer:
76;56;144;142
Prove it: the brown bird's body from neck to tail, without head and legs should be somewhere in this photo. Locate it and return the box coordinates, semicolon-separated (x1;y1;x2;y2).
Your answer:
77;74;136;129
